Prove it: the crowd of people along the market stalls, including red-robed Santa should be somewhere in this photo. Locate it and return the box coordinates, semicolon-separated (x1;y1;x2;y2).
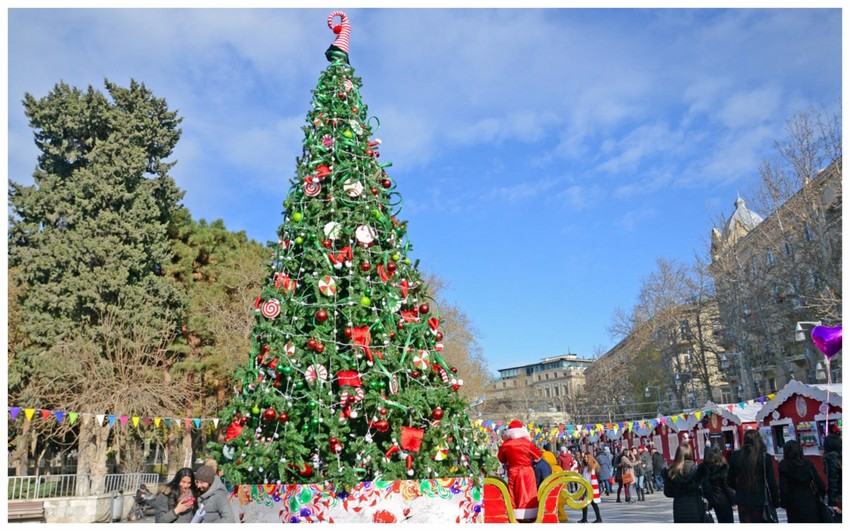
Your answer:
498;420;841;523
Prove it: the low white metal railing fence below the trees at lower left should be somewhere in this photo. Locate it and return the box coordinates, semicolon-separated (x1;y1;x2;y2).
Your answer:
8;473;159;500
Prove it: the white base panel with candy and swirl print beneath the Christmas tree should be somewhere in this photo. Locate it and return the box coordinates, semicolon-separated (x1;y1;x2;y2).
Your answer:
230;477;484;524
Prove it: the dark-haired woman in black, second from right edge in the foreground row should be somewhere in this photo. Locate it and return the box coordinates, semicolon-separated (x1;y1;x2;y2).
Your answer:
779;440;826;523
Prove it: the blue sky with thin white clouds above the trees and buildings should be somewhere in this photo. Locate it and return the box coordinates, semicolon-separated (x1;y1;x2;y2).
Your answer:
7;8;842;371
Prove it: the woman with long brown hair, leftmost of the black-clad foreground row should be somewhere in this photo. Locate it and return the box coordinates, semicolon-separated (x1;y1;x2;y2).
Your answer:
664;444;705;523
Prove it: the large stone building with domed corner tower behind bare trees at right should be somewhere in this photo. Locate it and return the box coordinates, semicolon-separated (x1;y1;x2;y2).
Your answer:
709;158;842;400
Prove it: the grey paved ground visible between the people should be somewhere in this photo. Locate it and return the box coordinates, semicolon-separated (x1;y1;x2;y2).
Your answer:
122;486;788;524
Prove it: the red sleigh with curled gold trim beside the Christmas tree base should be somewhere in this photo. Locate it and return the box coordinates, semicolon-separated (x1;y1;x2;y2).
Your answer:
484;471;593;523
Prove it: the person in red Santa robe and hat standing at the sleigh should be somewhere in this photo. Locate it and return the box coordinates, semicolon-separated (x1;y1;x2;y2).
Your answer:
498;420;543;520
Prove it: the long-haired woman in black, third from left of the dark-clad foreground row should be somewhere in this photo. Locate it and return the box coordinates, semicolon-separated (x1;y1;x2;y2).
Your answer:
727;429;779;523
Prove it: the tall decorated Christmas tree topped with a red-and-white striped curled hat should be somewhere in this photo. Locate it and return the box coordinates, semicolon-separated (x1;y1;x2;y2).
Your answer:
210;11;493;485
